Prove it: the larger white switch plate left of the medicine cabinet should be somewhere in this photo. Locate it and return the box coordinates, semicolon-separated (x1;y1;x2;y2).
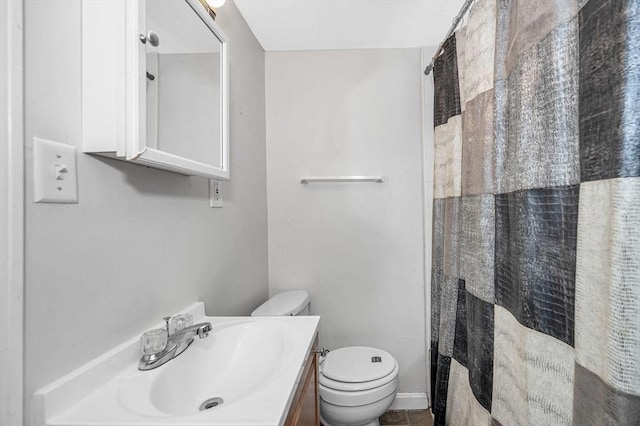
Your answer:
33;138;78;203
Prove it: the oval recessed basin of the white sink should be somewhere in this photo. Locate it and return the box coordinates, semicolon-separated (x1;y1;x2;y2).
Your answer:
118;320;295;416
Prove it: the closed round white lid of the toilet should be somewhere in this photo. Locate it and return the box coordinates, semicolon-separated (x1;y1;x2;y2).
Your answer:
322;346;396;383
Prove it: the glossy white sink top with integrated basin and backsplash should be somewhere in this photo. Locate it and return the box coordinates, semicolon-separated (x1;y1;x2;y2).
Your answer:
34;304;319;426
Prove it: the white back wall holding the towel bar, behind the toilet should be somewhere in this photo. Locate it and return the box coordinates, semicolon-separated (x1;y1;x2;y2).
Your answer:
266;49;427;393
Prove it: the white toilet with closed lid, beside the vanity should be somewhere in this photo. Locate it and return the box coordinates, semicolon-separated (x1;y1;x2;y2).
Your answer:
251;291;399;426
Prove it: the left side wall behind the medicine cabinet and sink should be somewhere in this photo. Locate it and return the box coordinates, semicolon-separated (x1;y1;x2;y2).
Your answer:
25;0;268;420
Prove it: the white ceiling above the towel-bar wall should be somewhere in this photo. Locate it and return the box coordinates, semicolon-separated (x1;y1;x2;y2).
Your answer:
234;0;464;51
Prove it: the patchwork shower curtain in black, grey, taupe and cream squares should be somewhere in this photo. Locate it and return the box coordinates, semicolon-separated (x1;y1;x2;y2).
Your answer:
431;0;640;426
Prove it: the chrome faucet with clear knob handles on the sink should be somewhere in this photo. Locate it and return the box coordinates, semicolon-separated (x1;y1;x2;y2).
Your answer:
138;317;212;371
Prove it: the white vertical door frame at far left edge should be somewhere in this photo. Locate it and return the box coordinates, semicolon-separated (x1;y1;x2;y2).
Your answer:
0;0;24;425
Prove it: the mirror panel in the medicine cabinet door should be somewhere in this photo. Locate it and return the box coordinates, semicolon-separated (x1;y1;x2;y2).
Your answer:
144;0;223;168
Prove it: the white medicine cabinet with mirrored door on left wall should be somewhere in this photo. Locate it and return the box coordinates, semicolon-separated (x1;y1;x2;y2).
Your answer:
82;0;229;180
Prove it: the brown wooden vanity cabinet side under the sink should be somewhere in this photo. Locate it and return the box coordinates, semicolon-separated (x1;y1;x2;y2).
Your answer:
284;337;320;426
